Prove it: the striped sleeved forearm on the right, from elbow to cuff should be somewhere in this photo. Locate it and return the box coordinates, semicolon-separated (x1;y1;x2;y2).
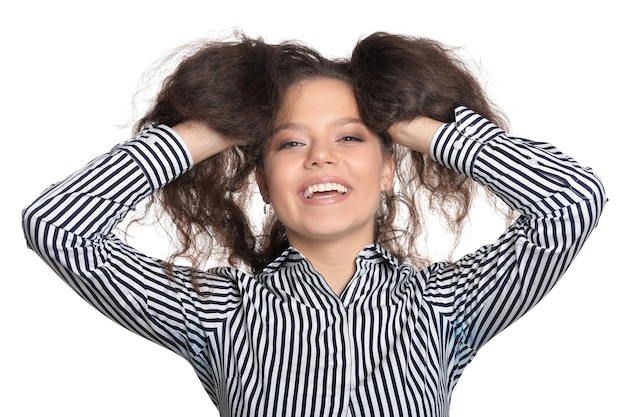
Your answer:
431;108;606;218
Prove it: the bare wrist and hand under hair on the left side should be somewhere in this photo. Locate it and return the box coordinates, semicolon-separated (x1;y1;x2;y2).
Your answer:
172;120;245;165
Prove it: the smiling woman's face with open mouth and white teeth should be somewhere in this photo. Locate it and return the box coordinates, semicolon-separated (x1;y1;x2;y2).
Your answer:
257;78;393;248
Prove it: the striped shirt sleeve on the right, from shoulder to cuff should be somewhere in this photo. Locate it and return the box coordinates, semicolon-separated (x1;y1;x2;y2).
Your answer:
425;107;606;351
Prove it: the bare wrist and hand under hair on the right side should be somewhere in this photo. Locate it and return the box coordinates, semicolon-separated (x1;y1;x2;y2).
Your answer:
387;116;443;154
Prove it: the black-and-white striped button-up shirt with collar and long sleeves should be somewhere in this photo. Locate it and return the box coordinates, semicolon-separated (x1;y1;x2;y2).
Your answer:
23;107;606;417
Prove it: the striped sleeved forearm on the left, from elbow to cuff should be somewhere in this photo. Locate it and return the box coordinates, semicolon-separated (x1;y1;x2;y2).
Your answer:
24;127;191;248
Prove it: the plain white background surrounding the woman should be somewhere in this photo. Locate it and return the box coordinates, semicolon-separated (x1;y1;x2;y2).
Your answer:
0;0;626;417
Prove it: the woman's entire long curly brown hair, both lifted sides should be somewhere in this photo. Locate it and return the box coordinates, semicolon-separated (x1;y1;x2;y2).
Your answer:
134;32;506;273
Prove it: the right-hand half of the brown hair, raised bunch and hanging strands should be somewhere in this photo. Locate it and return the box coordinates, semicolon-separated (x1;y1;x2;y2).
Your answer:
350;32;512;265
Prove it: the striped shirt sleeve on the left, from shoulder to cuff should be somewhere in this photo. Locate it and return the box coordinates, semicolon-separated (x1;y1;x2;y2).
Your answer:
23;126;236;358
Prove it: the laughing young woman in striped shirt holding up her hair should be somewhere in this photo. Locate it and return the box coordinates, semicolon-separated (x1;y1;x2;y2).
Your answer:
23;33;606;416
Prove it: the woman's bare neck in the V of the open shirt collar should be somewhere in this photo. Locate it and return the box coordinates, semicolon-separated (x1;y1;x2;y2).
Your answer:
290;234;371;295
